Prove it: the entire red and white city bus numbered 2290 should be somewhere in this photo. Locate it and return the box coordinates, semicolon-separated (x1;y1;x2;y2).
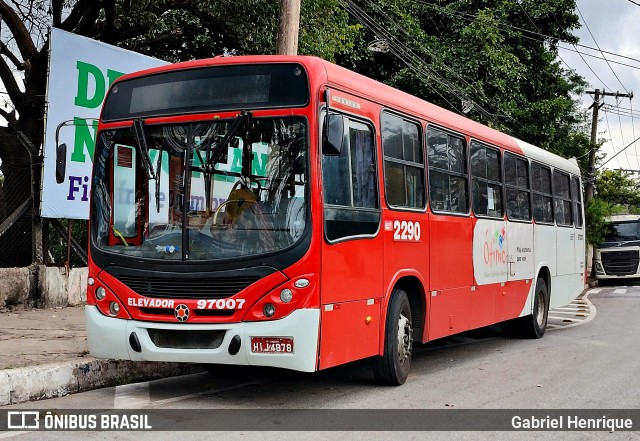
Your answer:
86;56;585;384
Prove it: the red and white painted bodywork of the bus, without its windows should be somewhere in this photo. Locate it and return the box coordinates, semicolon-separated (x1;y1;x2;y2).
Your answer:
87;56;584;382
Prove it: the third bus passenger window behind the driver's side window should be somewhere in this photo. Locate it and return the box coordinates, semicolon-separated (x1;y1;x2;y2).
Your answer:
471;141;502;217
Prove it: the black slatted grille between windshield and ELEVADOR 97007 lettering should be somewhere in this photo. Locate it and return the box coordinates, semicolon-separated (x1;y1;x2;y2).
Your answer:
117;275;259;299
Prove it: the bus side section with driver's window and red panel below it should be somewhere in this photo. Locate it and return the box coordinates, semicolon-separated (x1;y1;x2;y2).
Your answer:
320;114;383;369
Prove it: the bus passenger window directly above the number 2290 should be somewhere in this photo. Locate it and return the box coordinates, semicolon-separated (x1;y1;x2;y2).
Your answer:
382;112;426;208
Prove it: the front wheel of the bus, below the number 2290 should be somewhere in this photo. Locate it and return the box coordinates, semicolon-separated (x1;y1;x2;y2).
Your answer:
372;289;413;386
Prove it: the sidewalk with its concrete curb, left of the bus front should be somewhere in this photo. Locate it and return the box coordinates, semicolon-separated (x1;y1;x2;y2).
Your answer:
0;307;200;406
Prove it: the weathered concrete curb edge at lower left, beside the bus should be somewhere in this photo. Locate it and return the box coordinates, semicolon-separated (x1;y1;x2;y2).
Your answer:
0;357;202;406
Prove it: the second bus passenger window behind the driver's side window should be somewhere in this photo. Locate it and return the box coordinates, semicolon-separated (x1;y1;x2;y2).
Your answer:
427;127;469;213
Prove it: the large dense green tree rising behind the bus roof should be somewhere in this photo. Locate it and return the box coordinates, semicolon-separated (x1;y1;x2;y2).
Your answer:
340;0;590;162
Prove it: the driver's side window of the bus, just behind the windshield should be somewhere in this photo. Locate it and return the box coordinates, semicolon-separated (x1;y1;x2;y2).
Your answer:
322;119;380;241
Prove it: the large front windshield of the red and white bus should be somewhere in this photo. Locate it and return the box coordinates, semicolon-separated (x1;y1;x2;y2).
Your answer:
91;116;308;261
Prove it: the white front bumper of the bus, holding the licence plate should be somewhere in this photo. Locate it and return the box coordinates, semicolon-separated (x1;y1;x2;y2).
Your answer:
85;305;320;372
